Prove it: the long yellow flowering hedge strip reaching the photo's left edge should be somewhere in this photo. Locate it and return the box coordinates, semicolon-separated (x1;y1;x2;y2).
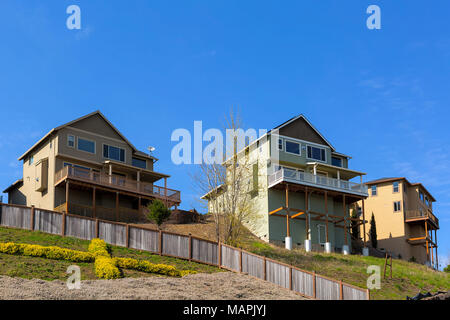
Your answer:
0;242;94;262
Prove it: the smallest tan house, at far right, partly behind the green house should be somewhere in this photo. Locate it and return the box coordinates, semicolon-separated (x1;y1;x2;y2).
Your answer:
358;178;439;267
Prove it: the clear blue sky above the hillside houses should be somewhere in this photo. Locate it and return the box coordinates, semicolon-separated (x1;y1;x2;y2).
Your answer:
0;0;450;268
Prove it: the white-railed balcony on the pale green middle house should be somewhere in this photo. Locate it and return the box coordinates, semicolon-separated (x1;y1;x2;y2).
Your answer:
268;168;368;197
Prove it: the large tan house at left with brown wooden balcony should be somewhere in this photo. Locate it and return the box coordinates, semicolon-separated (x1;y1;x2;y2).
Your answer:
4;111;180;222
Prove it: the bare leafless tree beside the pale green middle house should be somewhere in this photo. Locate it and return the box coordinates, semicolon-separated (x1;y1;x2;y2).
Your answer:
194;111;260;245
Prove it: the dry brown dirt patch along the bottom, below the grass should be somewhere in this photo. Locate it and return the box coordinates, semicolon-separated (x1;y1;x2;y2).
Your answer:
0;272;305;300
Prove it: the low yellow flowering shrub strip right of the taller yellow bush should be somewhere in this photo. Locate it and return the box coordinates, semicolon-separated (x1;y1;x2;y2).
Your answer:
114;258;197;277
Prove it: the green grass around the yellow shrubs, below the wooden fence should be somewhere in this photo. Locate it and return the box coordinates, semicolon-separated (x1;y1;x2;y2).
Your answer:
0;227;219;280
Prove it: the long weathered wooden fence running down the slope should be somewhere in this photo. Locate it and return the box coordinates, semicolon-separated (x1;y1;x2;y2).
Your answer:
0;204;370;300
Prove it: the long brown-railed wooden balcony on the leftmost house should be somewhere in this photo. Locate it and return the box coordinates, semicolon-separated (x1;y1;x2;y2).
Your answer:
55;166;181;204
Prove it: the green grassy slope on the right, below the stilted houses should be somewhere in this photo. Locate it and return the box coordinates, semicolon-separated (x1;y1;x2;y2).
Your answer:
242;239;450;300
